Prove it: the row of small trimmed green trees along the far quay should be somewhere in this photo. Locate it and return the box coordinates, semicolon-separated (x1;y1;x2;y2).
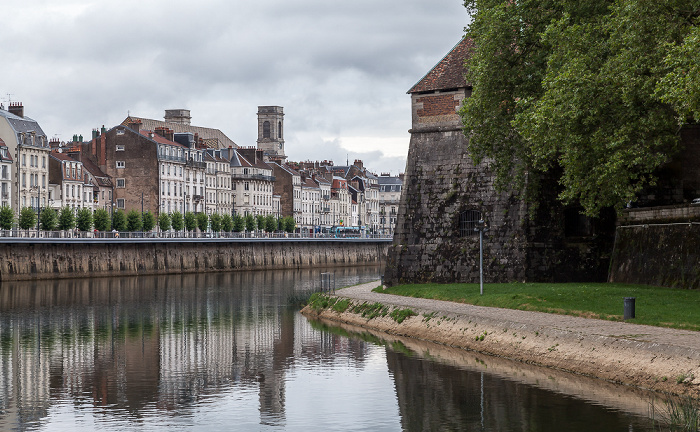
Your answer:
0;205;296;233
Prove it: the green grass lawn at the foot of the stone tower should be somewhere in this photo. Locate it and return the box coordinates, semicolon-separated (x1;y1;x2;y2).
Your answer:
374;283;700;331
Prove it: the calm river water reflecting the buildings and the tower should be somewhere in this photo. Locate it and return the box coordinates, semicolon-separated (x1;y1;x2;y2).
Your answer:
0;267;651;432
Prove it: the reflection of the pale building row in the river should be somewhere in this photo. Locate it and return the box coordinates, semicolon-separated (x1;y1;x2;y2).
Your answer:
0;268;379;429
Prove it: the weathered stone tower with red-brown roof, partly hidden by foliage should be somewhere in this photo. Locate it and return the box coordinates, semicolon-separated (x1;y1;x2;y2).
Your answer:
384;39;614;285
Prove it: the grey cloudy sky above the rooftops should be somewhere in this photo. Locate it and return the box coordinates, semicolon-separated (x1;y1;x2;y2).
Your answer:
0;0;468;174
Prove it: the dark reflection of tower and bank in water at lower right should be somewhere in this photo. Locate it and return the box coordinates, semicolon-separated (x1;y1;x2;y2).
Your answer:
308;322;653;432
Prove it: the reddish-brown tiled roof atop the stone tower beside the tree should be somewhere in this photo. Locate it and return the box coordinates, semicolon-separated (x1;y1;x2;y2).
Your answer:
407;38;473;94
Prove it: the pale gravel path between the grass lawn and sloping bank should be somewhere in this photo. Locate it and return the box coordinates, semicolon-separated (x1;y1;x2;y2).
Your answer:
336;281;700;352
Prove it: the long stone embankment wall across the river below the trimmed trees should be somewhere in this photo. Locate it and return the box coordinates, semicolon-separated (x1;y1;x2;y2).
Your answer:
0;240;389;281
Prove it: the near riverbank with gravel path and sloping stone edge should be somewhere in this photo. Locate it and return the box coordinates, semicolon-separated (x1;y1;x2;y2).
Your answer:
302;282;700;398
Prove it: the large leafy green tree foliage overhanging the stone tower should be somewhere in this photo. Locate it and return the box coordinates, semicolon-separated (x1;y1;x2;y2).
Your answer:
461;0;700;215
